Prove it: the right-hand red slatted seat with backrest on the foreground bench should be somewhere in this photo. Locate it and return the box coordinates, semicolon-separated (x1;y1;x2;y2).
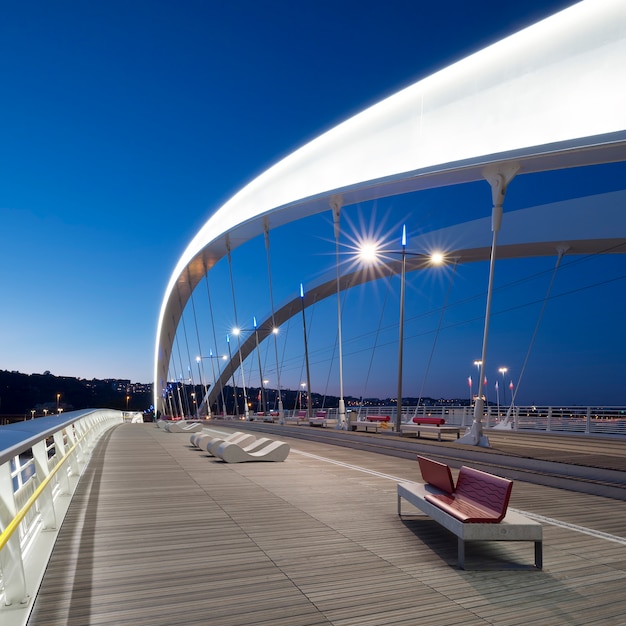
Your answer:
425;466;513;524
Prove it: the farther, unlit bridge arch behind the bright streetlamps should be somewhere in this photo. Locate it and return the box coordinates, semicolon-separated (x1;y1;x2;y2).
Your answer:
206;191;626;406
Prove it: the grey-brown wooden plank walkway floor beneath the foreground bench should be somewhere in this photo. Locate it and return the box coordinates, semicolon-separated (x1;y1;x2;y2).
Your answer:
29;424;626;626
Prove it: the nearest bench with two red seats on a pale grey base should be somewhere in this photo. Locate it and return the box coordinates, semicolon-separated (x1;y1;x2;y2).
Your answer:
398;456;543;569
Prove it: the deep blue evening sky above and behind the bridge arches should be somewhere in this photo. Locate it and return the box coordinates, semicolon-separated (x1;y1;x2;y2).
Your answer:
0;0;626;404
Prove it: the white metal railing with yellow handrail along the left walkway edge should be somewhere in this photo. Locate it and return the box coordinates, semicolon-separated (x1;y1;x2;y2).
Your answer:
0;409;124;626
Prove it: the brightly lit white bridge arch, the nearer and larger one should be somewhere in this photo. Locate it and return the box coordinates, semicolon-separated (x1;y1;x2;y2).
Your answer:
154;0;626;408
